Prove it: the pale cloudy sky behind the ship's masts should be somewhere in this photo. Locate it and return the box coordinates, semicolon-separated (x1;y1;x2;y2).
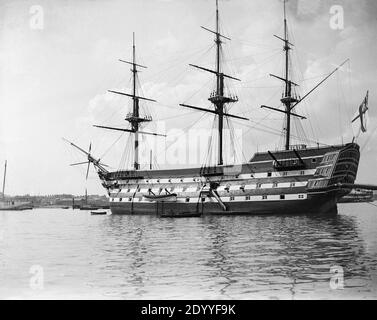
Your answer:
0;0;377;195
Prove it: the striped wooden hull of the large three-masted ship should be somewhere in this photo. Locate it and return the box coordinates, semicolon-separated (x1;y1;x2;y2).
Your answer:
102;144;360;216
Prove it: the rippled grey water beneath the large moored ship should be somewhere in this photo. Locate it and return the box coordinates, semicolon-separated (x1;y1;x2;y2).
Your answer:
0;202;377;299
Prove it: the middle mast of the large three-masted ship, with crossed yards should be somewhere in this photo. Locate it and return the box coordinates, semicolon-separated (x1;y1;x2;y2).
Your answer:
180;0;249;165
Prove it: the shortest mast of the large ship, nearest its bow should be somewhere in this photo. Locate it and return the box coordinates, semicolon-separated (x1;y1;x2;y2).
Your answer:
94;33;166;170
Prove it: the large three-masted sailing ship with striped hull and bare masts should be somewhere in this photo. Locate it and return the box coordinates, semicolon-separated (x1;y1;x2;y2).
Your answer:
65;0;374;216
